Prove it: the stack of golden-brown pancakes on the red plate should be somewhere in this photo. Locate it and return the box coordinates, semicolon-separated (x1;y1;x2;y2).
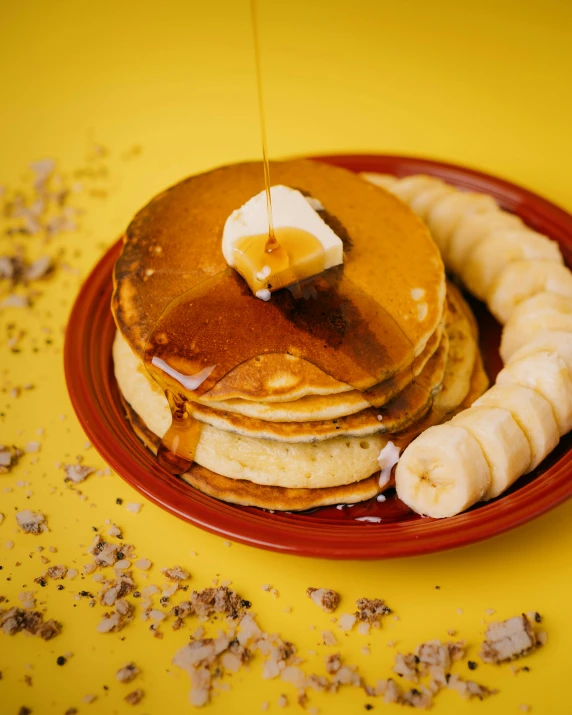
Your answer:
112;160;487;510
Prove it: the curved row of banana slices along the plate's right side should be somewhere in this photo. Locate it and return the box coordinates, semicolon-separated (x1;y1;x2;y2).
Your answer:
363;174;572;518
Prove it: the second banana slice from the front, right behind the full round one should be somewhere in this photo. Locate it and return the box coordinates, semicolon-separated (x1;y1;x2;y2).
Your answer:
450;407;531;500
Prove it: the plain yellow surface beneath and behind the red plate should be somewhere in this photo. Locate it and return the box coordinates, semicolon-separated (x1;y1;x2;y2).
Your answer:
0;0;572;715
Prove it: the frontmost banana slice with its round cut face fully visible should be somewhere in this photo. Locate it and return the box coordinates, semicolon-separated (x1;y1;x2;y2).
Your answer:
395;424;491;519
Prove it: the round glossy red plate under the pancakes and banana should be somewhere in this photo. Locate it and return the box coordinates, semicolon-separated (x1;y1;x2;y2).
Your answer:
65;155;572;559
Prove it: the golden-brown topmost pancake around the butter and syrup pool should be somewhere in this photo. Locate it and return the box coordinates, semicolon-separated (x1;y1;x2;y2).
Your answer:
112;160;445;402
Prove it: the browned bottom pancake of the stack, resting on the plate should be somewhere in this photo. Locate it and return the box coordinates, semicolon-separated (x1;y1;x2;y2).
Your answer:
121;397;388;511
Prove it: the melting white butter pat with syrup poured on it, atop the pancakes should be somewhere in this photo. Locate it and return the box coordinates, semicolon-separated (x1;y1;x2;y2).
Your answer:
222;186;344;300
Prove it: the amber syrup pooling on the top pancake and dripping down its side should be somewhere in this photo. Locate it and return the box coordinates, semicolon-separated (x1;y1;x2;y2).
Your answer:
145;266;414;474
